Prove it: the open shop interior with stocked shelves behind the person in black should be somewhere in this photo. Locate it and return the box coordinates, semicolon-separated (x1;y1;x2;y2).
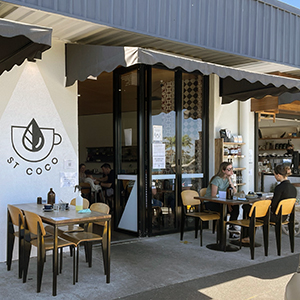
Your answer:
251;96;300;192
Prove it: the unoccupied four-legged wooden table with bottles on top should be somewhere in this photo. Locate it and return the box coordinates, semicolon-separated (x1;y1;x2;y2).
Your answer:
14;203;111;296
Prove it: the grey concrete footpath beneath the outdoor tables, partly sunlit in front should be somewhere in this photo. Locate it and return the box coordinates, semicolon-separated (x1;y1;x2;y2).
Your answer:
0;228;300;300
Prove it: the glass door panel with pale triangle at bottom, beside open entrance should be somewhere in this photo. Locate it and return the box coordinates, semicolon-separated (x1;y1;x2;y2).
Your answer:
114;68;139;234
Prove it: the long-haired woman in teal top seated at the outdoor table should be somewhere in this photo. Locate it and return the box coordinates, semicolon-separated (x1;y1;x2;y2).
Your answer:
205;162;239;237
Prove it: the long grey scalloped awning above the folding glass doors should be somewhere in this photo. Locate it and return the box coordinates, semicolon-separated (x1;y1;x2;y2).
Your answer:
66;44;300;103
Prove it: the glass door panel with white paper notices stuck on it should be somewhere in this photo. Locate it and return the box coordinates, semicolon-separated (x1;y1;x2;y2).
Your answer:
148;68;176;234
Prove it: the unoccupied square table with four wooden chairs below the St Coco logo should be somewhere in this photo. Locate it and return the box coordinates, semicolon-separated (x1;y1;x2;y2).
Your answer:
6;199;111;296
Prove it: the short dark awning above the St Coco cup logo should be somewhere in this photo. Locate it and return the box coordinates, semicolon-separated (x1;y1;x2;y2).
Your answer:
0;19;52;75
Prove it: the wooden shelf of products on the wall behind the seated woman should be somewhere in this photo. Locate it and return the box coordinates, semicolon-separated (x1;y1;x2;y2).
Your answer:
215;138;246;186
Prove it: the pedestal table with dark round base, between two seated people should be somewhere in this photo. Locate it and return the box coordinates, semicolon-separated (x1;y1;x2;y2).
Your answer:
195;196;261;251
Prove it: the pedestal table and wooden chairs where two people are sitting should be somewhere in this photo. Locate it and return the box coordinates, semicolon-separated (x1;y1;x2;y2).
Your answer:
180;188;296;259
